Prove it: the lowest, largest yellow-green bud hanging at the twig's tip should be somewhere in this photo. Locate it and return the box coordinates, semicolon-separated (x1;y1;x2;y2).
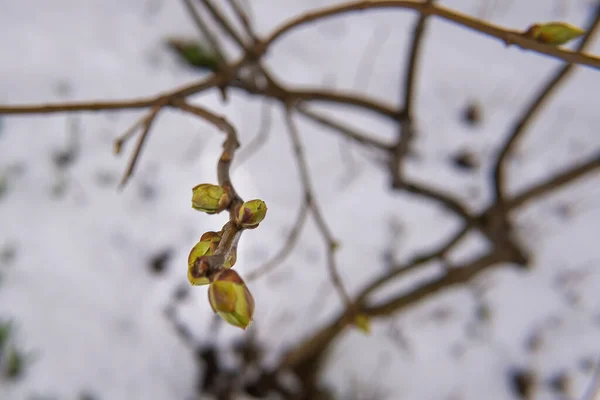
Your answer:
208;269;254;330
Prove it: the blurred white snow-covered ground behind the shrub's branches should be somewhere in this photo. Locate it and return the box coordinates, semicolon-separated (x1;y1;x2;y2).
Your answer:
0;0;600;400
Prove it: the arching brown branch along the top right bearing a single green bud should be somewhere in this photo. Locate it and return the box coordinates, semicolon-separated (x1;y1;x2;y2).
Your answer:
260;0;600;69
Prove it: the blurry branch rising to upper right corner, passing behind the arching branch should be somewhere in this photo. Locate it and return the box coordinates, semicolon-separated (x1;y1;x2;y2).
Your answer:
493;5;600;204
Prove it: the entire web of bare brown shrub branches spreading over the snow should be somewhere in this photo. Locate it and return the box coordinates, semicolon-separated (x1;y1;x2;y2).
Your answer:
0;0;600;396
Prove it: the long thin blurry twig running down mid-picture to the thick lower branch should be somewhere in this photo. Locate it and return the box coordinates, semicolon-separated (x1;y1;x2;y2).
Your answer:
285;104;351;307
